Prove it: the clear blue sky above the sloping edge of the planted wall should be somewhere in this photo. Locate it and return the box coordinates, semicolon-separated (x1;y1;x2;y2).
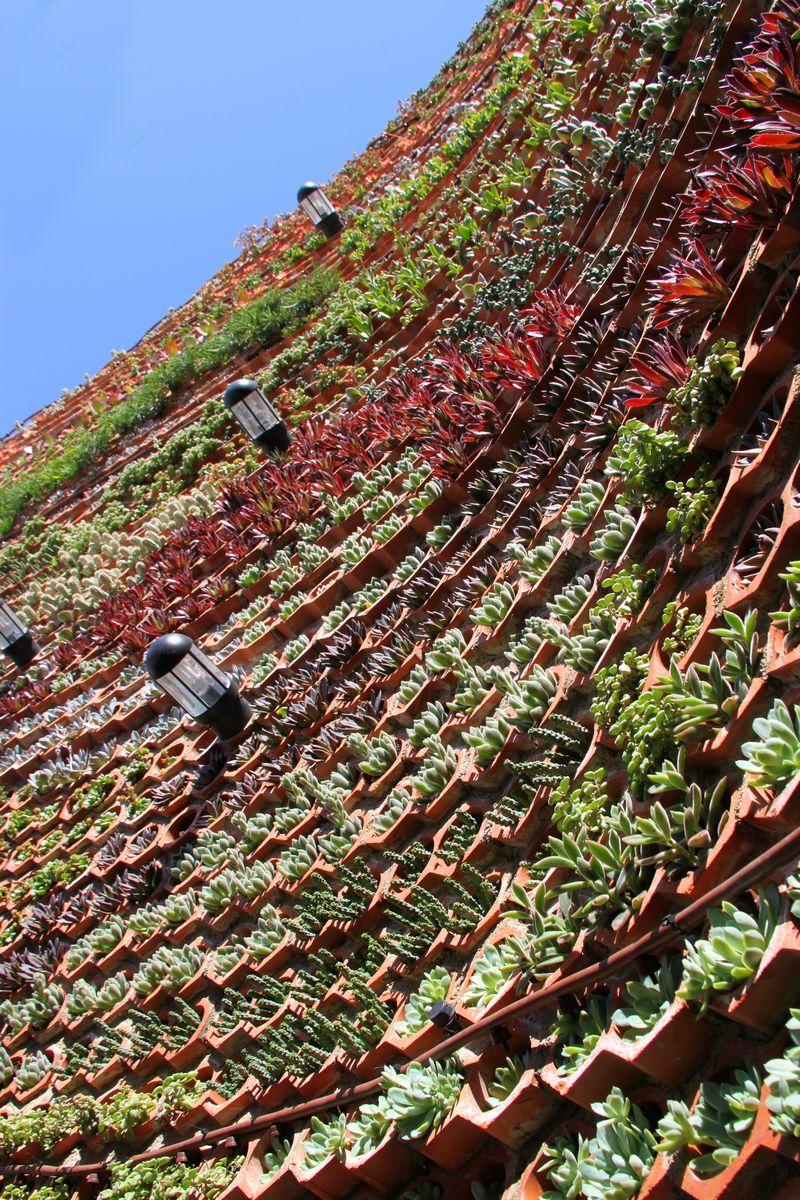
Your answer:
0;0;485;434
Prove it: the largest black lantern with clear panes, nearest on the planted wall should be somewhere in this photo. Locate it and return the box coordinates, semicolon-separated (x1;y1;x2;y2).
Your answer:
144;634;252;739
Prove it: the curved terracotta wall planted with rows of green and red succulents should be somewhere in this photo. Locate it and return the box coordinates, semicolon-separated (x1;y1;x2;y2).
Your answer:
0;0;800;1200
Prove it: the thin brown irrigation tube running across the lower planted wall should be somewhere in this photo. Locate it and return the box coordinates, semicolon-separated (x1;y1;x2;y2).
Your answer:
0;828;800;1180
